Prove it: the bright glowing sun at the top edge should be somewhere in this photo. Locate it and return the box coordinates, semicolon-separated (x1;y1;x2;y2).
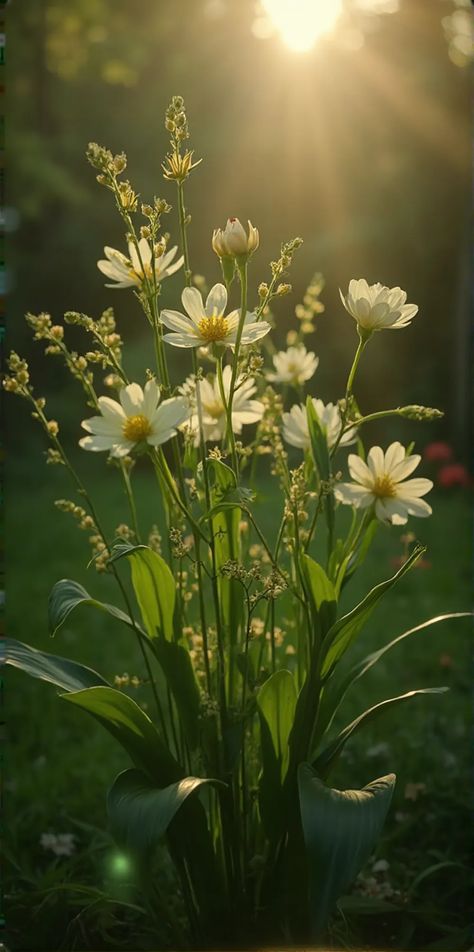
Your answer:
262;0;343;53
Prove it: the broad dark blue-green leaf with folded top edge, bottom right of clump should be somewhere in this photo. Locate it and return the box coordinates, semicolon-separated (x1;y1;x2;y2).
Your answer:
298;764;395;941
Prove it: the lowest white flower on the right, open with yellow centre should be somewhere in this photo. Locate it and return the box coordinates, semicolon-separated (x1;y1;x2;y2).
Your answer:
335;443;433;526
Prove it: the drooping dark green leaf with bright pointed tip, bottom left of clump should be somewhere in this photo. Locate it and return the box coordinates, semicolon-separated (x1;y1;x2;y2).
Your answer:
107;769;217;852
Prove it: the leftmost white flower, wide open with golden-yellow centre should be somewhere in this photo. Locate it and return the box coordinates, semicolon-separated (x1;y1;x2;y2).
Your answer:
79;380;189;457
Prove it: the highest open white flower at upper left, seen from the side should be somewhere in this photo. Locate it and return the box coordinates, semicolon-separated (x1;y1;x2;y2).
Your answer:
97;238;184;288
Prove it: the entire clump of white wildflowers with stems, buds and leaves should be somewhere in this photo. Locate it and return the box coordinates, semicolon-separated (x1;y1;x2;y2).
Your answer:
4;96;468;948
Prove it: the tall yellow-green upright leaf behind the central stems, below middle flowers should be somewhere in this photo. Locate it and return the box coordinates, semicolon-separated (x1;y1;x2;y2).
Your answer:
206;459;243;636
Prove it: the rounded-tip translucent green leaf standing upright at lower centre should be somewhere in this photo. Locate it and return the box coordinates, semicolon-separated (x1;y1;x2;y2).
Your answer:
257;669;297;838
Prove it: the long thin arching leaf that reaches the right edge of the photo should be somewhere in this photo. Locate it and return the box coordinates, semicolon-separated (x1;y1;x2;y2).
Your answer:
315;612;473;741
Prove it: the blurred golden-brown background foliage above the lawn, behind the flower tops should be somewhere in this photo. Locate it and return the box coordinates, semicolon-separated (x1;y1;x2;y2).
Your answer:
7;0;470;450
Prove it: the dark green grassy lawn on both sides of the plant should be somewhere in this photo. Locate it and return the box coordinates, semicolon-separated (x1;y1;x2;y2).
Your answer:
4;428;470;950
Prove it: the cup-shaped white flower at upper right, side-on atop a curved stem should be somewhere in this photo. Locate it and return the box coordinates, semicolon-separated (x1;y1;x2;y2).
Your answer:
339;278;418;331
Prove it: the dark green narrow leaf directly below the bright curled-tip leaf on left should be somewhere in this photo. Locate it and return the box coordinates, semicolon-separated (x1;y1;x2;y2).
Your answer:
153;639;201;750
